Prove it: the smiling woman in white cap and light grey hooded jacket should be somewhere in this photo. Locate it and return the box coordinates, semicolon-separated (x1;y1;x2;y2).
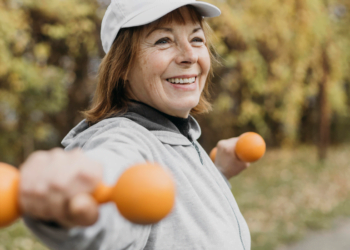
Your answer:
19;0;250;250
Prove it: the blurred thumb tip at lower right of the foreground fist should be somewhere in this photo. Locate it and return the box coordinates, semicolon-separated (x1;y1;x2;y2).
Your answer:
68;194;99;226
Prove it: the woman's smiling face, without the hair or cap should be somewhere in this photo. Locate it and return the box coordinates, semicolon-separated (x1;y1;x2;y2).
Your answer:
128;11;210;118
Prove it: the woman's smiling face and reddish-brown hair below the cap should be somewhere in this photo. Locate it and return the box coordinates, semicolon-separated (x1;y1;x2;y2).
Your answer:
84;5;216;124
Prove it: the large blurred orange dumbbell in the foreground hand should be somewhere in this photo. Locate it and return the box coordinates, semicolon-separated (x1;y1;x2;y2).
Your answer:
0;163;175;228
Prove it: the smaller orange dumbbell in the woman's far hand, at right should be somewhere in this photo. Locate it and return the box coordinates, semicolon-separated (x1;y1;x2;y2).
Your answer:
210;132;266;162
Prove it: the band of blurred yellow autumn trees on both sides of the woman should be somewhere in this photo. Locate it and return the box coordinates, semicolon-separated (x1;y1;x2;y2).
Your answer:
0;0;350;164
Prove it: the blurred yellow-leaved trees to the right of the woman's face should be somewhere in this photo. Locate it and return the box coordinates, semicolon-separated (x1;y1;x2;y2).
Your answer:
200;0;350;158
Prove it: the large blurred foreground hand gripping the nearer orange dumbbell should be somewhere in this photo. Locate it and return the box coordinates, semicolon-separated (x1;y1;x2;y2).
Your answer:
19;148;103;227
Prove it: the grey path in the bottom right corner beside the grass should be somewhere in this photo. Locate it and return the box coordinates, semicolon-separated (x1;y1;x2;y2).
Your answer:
277;219;350;250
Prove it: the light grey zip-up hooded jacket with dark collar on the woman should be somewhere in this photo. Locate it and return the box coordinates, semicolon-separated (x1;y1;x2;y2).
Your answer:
24;103;250;250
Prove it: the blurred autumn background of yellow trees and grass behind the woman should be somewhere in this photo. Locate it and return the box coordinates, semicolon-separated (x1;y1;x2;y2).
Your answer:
0;0;350;250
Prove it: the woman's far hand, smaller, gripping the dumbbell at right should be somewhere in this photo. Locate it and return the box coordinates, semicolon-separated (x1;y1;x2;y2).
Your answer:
215;137;249;179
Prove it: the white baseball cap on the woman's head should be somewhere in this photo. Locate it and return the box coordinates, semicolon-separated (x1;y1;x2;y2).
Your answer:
101;0;221;53
